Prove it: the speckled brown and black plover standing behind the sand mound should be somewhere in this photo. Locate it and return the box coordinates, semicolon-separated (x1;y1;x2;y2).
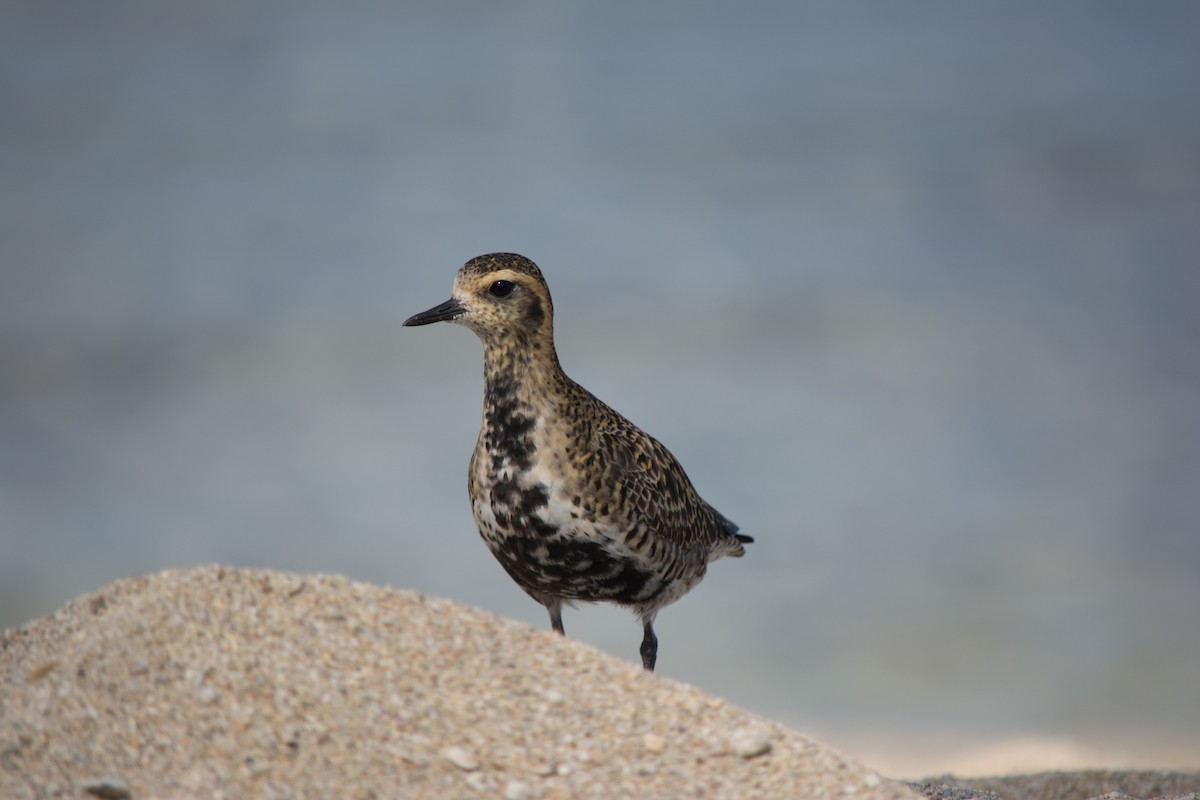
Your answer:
404;253;754;672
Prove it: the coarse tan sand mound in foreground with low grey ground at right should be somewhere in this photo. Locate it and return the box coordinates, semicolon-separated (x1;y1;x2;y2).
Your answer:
0;567;1200;800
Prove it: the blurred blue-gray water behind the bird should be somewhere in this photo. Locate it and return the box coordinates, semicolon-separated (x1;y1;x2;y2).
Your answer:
0;0;1200;753
